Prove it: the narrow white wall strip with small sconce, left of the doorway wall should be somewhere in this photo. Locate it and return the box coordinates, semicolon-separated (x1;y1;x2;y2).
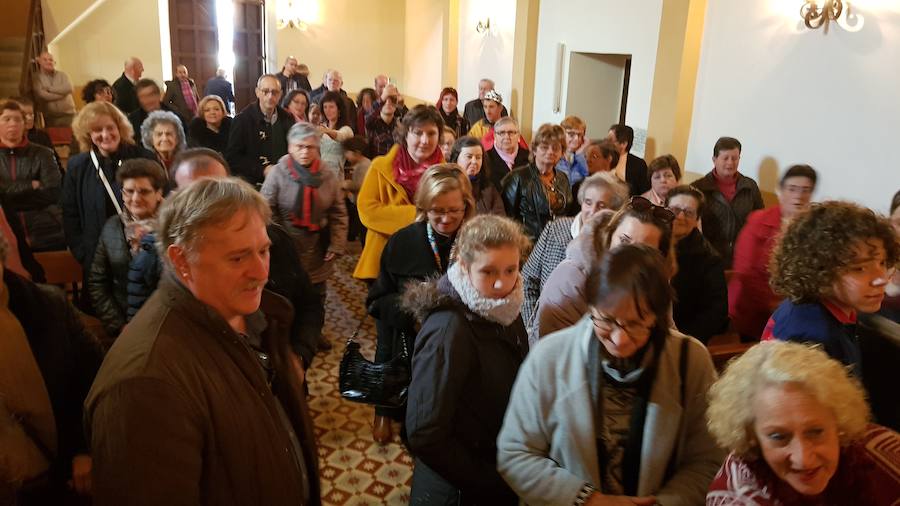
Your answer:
458;0;516;105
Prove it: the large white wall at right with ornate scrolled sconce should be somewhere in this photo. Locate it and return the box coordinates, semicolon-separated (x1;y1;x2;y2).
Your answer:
685;0;900;212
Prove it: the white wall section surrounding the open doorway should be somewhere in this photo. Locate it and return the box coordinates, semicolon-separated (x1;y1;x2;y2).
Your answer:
533;0;664;137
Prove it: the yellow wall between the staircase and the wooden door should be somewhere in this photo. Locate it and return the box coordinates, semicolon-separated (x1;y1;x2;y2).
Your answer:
45;0;163;86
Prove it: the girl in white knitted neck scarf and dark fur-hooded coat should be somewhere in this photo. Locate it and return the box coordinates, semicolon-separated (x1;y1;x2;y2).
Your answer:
403;215;531;505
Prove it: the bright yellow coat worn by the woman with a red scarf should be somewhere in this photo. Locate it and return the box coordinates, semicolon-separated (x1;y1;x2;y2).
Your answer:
353;144;416;279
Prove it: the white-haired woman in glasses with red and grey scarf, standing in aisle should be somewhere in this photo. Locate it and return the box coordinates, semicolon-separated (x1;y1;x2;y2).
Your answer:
260;123;348;349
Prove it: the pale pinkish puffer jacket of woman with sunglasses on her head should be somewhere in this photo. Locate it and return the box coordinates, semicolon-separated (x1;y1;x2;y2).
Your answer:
533;211;615;337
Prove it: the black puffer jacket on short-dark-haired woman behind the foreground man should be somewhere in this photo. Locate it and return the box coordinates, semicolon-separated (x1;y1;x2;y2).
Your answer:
87;216;131;344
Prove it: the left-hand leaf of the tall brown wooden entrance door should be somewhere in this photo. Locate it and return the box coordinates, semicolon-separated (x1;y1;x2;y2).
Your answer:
169;0;219;97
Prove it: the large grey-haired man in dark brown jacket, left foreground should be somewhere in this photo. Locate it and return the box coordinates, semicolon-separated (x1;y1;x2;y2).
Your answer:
85;178;321;506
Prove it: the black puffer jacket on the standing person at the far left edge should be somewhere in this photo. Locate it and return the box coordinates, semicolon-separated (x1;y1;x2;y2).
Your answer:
0;141;66;251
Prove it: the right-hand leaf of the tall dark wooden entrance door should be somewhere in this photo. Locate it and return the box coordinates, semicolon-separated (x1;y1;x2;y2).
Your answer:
234;0;266;112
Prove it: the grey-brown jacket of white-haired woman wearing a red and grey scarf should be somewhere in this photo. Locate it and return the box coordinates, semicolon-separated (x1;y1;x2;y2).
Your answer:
260;155;347;284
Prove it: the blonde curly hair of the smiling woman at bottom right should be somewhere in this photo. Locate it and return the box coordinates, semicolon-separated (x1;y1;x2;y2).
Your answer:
706;341;871;459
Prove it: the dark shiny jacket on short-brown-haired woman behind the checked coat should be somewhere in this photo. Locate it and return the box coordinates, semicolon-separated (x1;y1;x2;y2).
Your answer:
501;163;572;240
